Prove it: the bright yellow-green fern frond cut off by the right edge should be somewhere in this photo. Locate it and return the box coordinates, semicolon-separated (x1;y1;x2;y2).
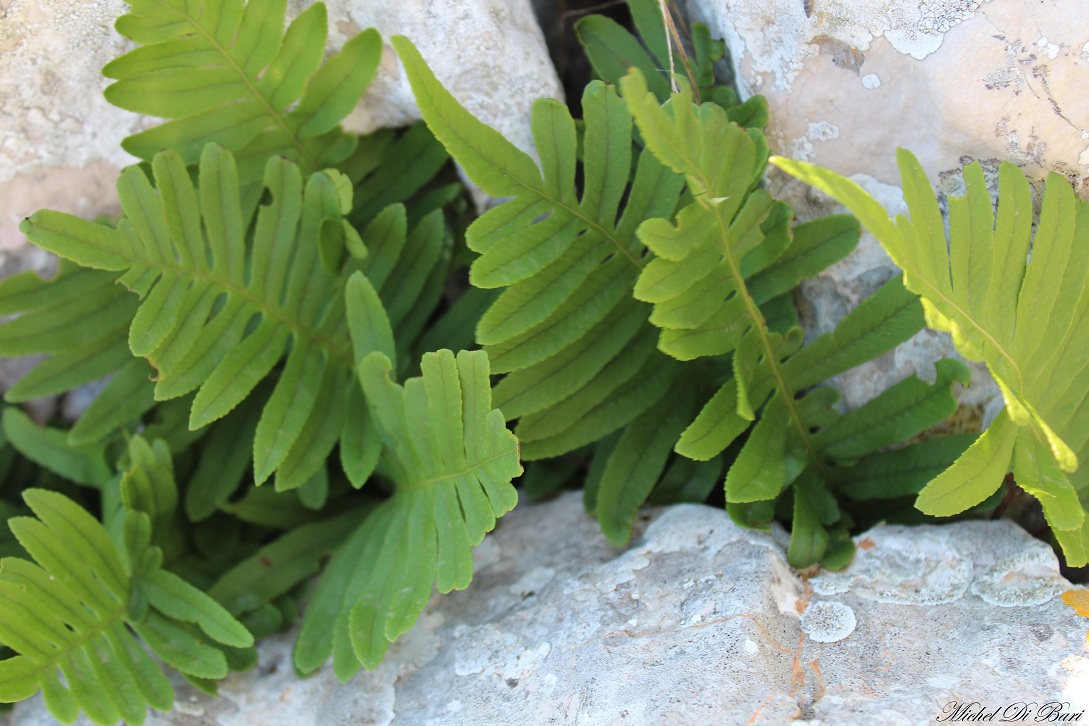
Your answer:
774;149;1089;566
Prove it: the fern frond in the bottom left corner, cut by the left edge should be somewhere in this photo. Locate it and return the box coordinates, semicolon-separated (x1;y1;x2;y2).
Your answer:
0;490;253;724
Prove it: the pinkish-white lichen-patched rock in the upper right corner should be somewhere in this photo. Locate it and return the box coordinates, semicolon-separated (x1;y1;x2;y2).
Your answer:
686;0;1089;423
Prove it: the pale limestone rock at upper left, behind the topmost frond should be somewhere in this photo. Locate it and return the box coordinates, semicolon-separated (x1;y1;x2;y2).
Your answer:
0;0;561;249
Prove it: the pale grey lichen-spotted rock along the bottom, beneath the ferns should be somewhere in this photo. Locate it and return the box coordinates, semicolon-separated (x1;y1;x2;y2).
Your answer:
12;493;1089;726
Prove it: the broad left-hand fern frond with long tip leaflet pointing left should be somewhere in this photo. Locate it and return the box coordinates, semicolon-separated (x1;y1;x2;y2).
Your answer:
22;145;405;490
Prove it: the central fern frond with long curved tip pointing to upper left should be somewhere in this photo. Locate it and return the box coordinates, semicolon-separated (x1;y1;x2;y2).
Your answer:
393;37;682;459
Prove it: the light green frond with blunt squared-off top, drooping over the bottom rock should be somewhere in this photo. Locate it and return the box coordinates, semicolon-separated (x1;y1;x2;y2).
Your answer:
295;350;522;680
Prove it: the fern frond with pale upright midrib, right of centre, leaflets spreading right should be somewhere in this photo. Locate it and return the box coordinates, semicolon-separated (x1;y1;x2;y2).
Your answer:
618;71;984;566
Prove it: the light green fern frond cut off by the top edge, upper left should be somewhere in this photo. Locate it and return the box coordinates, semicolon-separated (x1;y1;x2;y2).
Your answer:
102;0;382;187
